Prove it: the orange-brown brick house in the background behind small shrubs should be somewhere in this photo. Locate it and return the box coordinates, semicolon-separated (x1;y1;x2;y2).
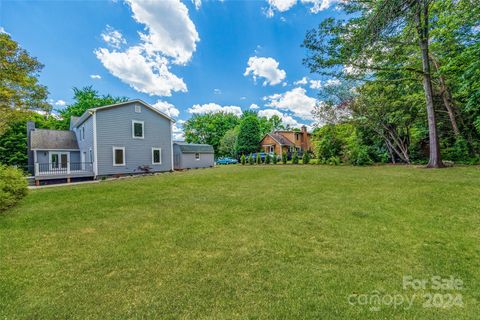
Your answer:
260;126;312;155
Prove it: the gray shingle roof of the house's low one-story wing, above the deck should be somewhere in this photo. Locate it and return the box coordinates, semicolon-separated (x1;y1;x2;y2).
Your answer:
30;129;78;150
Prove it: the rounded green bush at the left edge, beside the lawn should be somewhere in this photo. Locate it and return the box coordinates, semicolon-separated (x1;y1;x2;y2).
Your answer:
0;165;28;212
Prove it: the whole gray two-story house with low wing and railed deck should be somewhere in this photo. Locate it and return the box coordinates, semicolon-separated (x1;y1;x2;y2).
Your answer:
27;100;174;185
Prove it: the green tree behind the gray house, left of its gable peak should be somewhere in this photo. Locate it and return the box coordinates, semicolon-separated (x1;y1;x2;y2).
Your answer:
57;86;128;130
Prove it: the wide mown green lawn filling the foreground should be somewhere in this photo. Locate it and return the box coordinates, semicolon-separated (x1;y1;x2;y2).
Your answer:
0;165;480;320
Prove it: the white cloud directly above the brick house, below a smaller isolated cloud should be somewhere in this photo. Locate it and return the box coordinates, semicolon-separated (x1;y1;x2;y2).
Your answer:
263;87;317;120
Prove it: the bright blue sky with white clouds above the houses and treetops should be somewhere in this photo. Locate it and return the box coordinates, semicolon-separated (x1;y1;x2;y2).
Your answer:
0;0;339;136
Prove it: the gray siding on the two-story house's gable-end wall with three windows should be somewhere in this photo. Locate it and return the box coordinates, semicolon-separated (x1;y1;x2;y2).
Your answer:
96;103;172;176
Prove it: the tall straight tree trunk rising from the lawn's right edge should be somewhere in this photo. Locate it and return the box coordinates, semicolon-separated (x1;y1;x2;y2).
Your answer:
415;0;444;168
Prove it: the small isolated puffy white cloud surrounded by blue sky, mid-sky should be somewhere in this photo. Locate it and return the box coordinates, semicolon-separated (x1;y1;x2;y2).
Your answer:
243;56;287;86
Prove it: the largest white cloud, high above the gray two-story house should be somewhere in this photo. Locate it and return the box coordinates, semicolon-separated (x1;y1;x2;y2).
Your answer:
95;0;200;96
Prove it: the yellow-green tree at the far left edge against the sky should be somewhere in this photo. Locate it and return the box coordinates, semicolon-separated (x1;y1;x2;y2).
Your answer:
0;33;51;134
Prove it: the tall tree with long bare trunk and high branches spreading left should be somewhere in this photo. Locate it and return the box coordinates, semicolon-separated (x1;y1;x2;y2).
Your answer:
304;0;450;167
